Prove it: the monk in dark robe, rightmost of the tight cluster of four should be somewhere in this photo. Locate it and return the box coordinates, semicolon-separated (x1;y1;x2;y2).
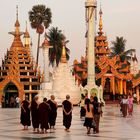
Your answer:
47;95;58;132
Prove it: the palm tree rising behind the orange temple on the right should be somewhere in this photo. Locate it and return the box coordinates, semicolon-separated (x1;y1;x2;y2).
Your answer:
111;36;135;61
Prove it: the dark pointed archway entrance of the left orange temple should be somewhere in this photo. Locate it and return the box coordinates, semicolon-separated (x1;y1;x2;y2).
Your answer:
3;82;19;108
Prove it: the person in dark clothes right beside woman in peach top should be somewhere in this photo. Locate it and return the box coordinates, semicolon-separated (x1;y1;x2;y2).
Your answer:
93;96;103;133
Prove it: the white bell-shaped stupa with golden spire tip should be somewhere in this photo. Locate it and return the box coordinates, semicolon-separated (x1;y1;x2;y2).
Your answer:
52;43;80;105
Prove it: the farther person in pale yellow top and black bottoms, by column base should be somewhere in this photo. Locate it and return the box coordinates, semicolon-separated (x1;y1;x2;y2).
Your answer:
80;94;86;118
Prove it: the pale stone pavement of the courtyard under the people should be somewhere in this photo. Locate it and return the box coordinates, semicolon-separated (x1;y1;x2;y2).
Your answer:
0;105;140;140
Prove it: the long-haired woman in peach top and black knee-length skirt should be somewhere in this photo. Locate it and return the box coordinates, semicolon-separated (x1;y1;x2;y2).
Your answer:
84;98;93;134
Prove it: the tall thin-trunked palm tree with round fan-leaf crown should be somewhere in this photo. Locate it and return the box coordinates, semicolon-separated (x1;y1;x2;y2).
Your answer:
28;5;52;66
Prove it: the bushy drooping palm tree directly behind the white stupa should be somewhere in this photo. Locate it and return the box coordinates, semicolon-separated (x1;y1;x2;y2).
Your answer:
47;27;70;66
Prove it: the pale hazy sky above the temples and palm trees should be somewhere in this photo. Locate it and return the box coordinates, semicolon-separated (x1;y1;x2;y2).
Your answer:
0;0;140;68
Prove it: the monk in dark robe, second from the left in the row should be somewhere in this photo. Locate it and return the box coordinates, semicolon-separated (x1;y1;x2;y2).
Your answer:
31;96;39;133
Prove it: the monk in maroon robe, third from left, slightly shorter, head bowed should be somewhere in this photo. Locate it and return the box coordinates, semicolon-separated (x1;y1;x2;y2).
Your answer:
39;98;50;133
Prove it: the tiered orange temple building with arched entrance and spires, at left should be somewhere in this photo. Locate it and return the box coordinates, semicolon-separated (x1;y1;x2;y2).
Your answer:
0;8;40;107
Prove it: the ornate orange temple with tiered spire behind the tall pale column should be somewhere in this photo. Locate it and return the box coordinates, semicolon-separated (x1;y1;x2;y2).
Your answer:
73;9;140;101
